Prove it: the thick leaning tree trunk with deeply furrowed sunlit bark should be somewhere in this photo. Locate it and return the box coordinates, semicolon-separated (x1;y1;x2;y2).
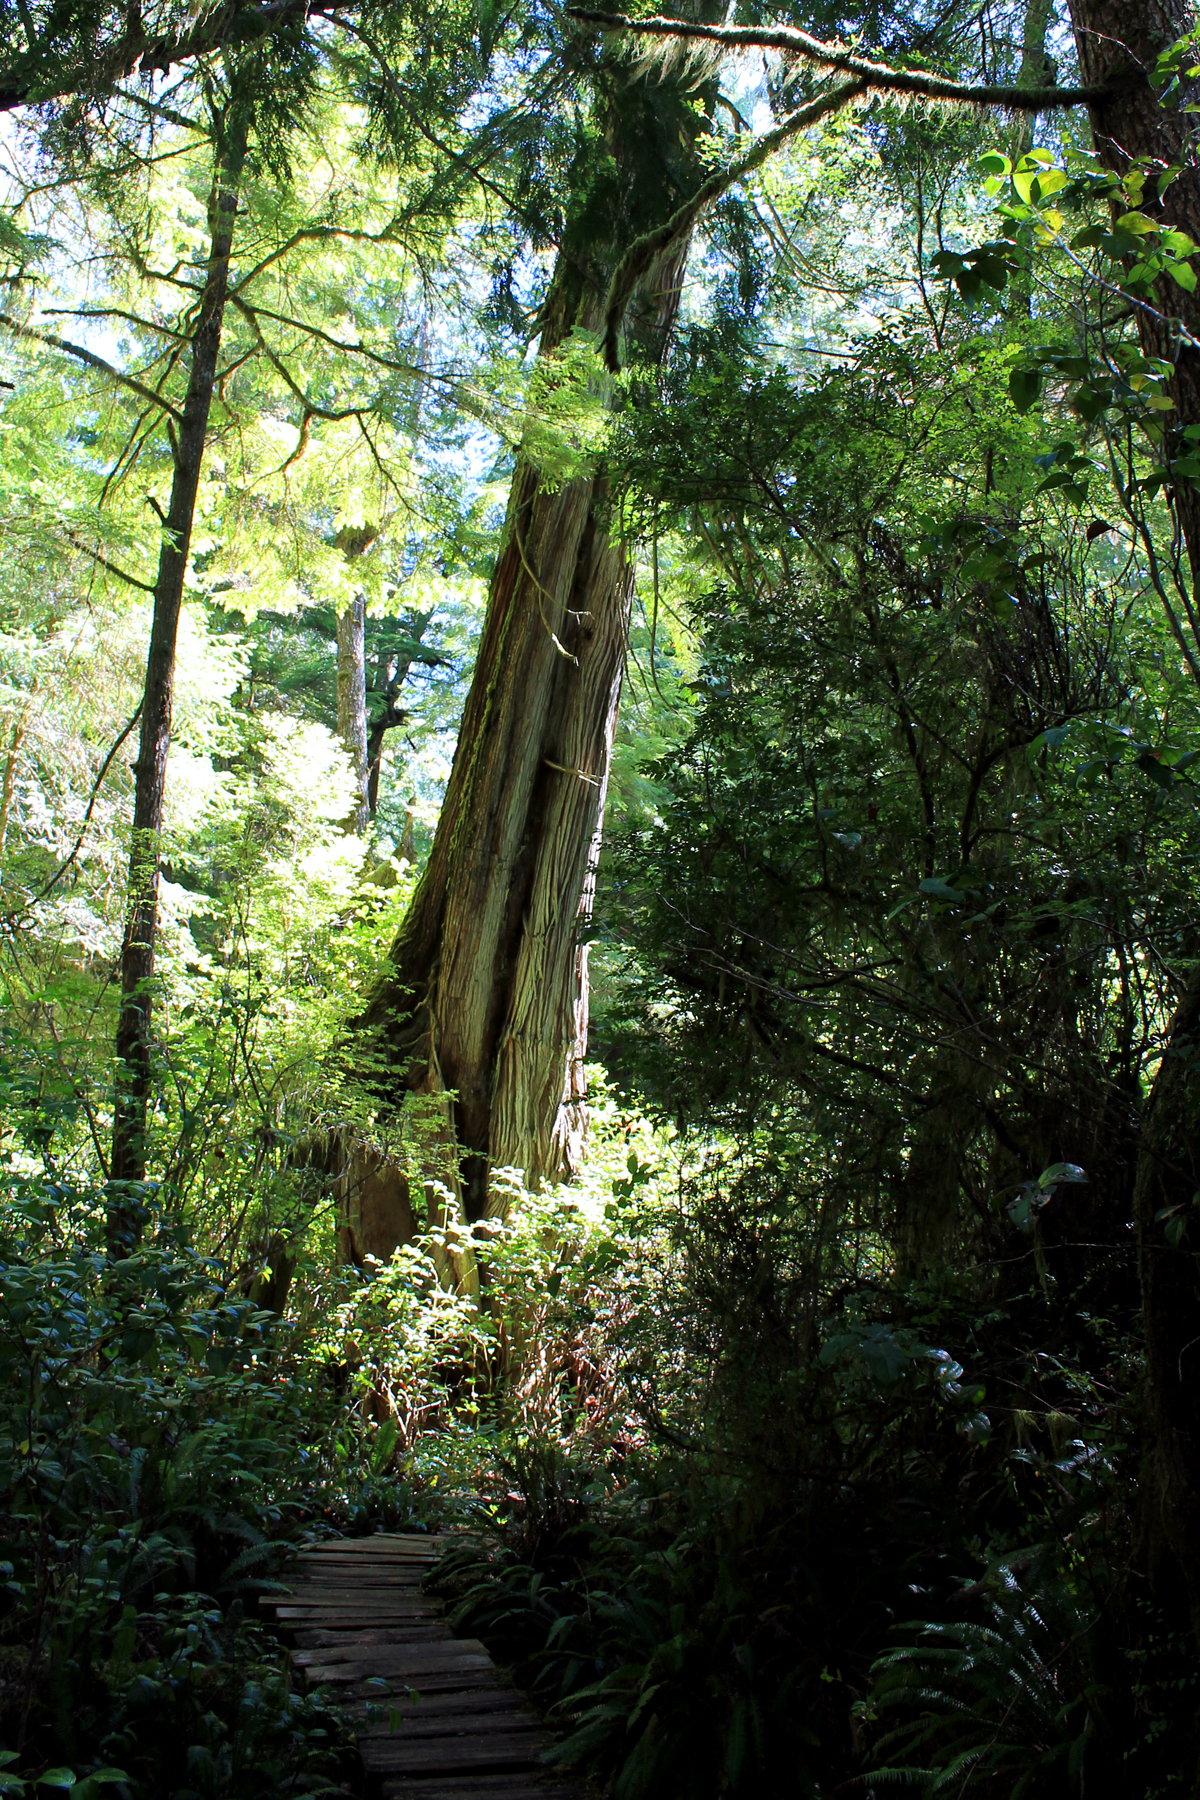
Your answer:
349;45;702;1252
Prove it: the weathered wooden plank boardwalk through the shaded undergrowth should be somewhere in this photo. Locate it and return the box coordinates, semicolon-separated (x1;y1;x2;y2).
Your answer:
261;1535;583;1800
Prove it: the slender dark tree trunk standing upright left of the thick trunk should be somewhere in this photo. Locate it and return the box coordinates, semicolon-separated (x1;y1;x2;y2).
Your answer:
108;106;246;1251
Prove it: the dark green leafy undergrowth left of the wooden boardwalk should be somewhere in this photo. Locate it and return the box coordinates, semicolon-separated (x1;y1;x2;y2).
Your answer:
0;1179;352;1800
